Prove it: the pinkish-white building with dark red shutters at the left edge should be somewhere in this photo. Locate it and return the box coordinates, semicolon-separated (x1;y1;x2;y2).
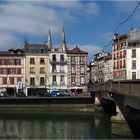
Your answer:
0;49;25;95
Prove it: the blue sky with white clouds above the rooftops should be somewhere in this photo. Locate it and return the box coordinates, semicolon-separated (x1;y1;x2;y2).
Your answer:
0;0;140;61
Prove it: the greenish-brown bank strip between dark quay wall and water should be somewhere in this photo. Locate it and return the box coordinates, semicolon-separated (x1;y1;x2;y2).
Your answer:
0;104;101;113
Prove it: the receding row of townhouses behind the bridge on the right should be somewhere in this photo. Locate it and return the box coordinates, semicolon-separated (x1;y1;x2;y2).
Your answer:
90;28;140;84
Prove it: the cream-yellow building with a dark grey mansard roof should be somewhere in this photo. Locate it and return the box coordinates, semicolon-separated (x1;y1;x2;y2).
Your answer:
24;44;49;96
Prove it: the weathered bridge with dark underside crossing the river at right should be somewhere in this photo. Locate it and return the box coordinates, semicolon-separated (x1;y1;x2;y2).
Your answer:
93;80;140;138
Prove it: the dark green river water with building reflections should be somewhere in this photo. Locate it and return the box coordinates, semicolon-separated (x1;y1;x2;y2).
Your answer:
0;112;134;139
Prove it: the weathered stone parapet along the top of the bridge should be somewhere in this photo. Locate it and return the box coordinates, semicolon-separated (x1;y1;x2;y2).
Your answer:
94;80;140;98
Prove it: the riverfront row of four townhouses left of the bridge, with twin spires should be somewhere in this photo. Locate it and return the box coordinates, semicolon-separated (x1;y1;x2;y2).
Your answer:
0;29;88;96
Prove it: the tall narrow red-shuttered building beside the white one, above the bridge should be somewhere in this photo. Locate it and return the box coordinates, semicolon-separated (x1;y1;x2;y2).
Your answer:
112;34;128;80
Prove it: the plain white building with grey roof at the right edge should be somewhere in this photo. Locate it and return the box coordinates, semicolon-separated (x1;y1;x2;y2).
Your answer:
127;28;140;79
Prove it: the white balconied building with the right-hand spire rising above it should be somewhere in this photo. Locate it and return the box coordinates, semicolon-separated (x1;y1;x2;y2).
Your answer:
49;30;68;89
